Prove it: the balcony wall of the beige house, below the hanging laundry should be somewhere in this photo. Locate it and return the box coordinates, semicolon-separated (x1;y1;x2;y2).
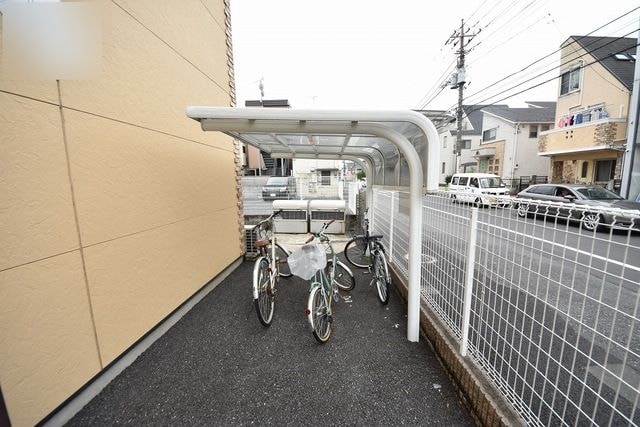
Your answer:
538;117;627;156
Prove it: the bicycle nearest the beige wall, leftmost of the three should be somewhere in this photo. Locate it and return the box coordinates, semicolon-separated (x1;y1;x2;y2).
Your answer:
253;210;292;327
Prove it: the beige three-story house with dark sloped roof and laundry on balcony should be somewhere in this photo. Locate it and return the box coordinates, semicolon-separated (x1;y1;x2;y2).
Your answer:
538;36;637;189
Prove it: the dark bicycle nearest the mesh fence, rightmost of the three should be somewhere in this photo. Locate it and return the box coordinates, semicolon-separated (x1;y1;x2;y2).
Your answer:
344;208;391;304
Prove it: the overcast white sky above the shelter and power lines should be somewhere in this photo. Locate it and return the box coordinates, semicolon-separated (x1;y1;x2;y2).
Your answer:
231;0;640;110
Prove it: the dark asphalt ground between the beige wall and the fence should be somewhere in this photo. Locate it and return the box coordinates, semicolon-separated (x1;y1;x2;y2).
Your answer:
68;252;474;426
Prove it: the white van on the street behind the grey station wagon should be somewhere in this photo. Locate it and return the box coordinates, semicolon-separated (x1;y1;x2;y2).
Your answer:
448;173;509;206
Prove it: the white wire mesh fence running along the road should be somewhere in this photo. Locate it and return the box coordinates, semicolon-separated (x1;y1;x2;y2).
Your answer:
372;190;640;425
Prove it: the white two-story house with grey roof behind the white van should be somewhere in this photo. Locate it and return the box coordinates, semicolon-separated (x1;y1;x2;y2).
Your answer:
480;101;556;178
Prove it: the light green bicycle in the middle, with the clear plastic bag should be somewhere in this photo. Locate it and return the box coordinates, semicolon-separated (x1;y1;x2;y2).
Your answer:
305;220;355;343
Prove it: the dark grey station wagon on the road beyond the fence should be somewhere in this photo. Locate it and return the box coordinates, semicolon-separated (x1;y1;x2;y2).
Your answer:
515;184;640;231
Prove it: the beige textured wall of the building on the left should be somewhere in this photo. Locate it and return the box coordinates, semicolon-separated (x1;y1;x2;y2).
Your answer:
0;0;242;426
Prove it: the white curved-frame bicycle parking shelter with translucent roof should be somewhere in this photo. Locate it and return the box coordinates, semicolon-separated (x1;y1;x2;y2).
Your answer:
186;106;440;342
